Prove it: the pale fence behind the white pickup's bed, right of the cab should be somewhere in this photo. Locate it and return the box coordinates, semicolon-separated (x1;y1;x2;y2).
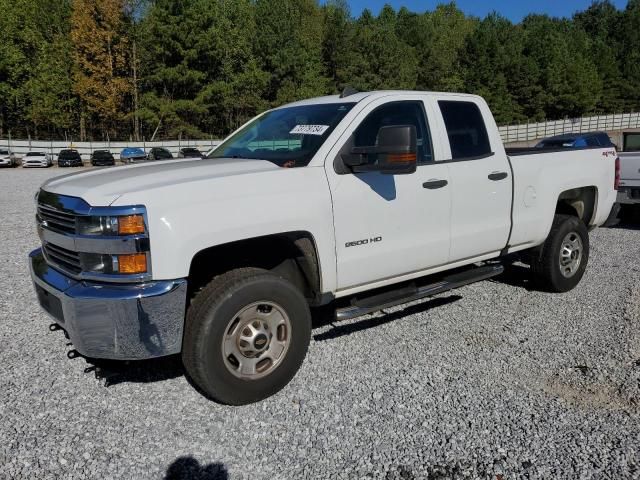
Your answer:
499;113;640;143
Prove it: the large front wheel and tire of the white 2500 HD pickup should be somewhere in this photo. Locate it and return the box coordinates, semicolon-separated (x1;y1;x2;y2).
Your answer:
182;268;311;405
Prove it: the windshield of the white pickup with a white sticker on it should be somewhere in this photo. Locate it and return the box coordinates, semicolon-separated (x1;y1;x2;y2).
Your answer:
212;103;355;168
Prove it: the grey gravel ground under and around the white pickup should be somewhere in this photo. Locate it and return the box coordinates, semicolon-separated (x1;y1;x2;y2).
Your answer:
0;169;640;479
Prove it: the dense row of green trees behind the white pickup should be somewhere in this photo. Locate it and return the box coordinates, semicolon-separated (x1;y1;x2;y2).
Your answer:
0;0;640;139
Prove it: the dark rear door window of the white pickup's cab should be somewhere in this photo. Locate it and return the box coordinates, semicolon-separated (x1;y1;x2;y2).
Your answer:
438;100;491;160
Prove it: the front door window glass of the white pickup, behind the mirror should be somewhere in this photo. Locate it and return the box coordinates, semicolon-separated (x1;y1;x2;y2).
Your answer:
353;101;433;165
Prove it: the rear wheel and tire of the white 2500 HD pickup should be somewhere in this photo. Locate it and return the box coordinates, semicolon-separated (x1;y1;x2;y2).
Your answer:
530;215;589;293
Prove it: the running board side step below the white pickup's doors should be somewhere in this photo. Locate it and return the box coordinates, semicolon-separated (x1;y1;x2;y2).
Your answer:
336;265;504;321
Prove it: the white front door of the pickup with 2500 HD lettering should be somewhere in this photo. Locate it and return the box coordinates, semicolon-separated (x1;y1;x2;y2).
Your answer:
325;94;451;291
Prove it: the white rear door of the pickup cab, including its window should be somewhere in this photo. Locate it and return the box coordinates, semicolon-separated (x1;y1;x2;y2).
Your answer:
434;96;513;262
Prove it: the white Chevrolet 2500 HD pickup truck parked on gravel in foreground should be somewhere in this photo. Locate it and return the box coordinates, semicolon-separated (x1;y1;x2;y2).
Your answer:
30;91;619;404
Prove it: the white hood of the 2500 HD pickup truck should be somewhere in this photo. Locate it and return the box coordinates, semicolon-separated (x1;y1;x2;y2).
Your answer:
42;158;279;207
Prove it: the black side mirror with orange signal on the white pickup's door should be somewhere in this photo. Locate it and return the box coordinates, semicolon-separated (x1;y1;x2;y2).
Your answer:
342;125;418;175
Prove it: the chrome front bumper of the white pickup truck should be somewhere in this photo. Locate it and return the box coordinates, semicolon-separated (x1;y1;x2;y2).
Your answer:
29;249;187;360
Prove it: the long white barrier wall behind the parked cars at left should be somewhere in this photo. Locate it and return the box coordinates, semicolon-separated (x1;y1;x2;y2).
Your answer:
0;138;220;161
